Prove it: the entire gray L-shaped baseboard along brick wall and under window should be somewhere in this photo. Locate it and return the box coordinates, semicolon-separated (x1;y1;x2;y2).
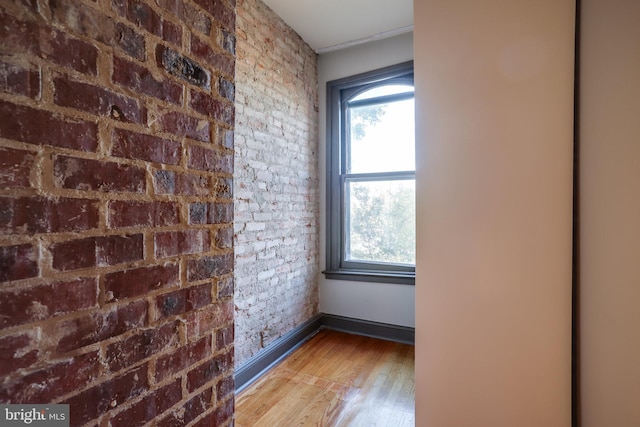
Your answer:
235;314;415;393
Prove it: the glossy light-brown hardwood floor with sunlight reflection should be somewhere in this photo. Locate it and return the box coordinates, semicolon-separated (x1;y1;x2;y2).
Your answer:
235;329;415;427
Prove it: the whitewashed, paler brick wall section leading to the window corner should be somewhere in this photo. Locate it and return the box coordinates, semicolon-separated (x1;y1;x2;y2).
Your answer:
234;0;319;366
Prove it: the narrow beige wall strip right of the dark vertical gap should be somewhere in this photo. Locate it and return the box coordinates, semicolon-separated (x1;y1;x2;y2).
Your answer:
579;0;640;427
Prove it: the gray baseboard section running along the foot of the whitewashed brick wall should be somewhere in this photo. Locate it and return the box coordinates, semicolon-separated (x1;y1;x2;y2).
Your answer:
234;314;322;393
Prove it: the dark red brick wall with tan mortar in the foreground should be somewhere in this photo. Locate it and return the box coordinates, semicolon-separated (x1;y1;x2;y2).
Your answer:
0;0;236;426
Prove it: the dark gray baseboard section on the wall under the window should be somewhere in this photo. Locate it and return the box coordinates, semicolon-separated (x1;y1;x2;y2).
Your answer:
322;314;416;345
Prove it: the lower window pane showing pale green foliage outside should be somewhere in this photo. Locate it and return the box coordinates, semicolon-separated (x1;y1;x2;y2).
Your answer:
345;179;416;265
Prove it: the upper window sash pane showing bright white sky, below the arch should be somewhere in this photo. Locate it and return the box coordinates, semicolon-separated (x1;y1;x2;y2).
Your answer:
347;99;415;173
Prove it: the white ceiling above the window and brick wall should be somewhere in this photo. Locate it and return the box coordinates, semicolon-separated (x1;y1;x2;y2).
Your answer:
263;0;413;53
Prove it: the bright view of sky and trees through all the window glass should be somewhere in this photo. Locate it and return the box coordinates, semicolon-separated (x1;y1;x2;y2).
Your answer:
345;86;415;265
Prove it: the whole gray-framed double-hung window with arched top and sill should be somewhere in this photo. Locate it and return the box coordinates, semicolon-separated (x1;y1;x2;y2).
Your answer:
324;62;416;284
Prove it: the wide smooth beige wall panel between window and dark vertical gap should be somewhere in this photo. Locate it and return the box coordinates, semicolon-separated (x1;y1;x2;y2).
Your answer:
414;0;575;427
